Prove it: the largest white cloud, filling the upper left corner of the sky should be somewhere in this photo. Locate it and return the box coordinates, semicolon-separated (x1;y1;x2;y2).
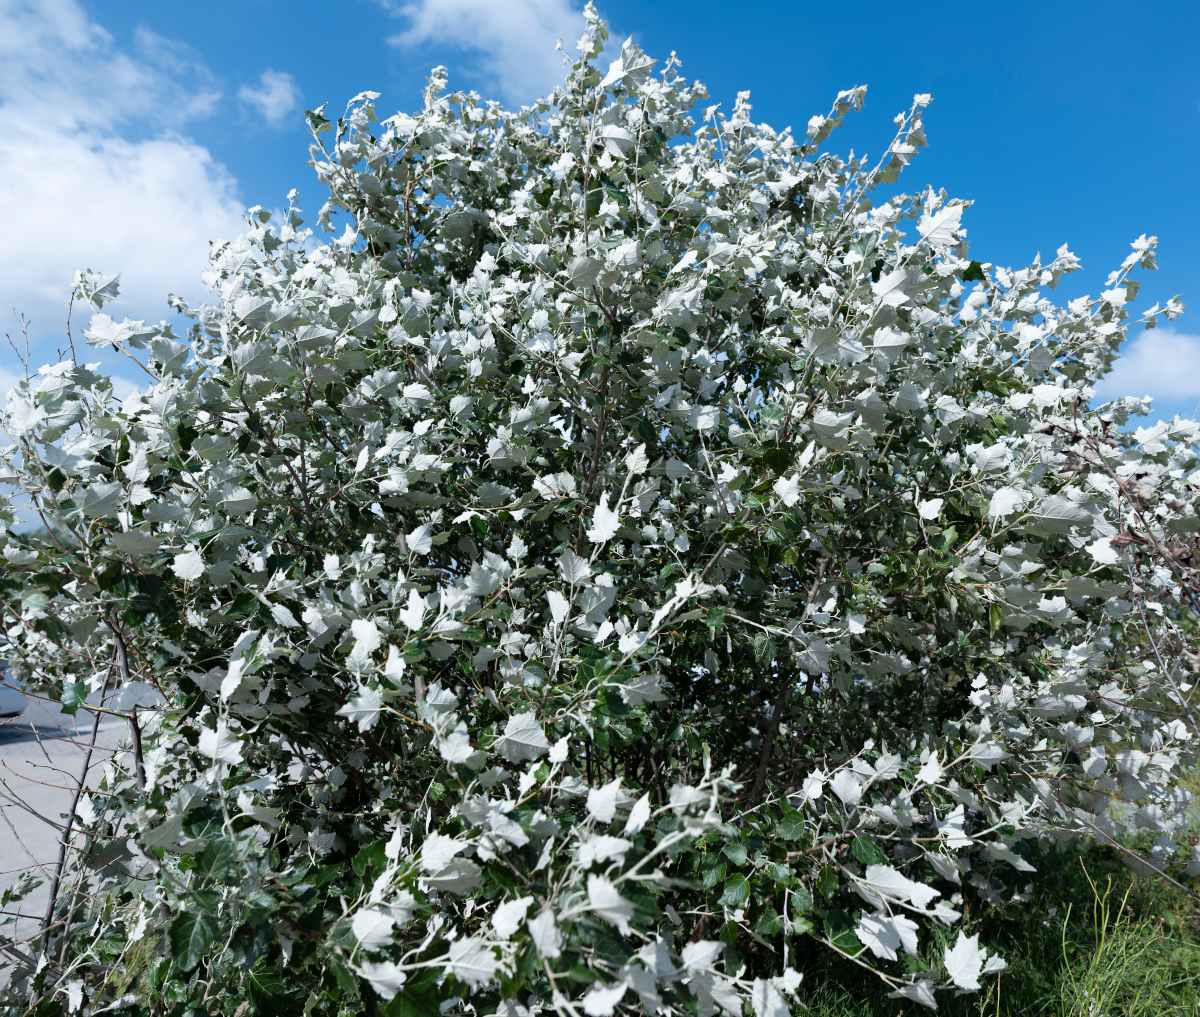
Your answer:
0;0;245;347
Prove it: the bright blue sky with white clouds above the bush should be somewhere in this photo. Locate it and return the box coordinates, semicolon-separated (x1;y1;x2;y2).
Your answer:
0;0;1200;415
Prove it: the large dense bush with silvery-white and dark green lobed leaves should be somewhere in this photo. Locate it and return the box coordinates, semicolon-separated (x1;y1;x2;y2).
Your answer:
0;10;1200;1017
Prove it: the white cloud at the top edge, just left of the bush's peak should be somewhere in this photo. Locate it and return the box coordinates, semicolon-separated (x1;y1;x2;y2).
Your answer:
385;0;584;101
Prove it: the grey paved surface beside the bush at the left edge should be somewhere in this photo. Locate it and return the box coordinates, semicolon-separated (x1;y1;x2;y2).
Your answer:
0;699;127;983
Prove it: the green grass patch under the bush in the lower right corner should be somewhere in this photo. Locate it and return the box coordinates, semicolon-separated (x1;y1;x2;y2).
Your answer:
802;849;1200;1017
